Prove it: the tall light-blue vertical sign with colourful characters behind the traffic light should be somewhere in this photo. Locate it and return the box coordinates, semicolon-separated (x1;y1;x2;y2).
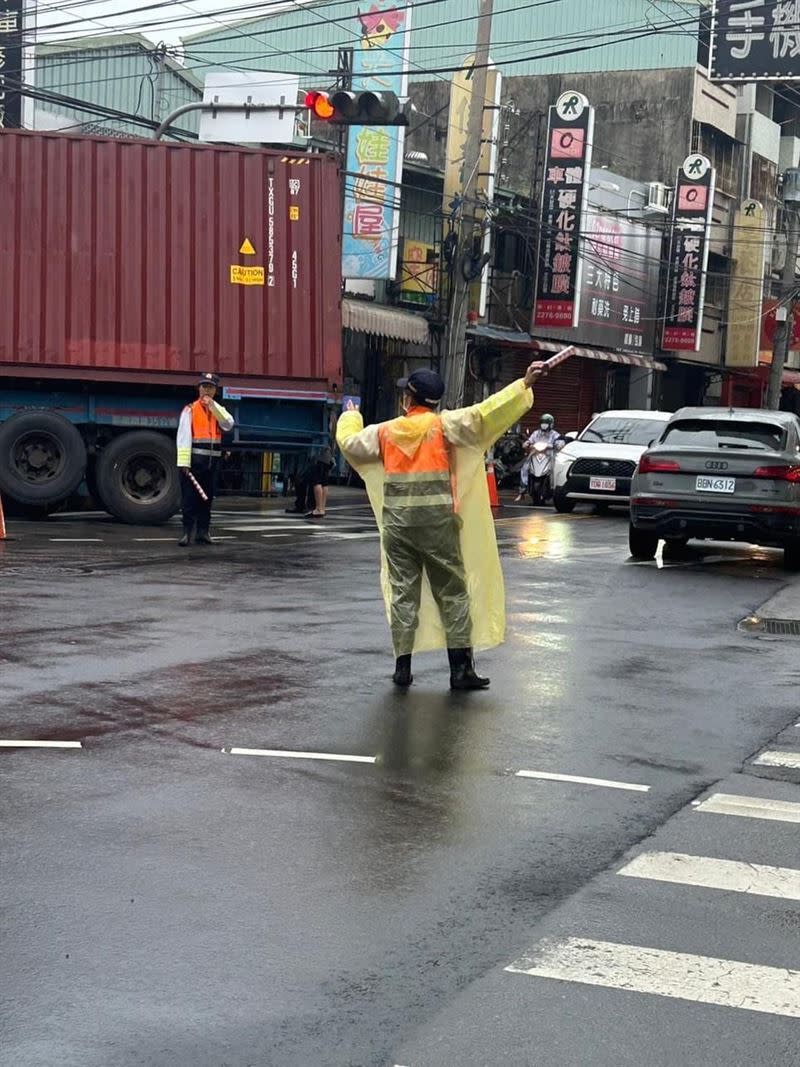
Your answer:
342;0;411;278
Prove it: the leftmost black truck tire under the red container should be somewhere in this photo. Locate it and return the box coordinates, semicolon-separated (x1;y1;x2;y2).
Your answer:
0;411;86;507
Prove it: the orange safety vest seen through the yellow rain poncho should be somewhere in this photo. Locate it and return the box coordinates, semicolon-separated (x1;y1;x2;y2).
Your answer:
378;408;454;512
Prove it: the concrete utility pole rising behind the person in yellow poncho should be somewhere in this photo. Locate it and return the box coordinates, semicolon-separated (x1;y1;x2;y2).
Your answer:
445;0;494;407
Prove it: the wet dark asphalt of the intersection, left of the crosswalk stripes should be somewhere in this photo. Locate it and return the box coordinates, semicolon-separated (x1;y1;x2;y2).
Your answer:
0;497;800;1067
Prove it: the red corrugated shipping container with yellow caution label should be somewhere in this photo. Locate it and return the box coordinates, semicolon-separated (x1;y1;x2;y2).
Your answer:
0;130;341;388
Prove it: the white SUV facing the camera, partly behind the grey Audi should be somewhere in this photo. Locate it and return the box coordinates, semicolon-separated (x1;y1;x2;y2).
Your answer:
553;411;672;513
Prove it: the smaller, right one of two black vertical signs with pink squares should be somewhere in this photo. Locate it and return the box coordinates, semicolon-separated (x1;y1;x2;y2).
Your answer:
662;155;715;352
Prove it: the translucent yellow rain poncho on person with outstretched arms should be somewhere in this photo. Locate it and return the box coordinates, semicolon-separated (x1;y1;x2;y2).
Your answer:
336;380;533;654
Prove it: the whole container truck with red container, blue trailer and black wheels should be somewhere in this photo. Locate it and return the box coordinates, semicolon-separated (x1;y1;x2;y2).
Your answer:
0;130;341;524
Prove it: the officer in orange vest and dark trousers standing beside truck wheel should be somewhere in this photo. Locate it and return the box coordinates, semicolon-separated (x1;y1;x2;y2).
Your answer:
177;373;234;548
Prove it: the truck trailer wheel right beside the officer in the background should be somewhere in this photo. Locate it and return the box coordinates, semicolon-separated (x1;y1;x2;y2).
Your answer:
96;430;180;526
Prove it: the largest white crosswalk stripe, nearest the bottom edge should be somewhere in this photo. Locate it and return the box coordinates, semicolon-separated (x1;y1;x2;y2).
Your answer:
506;937;800;1019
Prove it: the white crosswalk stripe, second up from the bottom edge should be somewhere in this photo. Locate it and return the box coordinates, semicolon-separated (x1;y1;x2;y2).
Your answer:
617;853;800;901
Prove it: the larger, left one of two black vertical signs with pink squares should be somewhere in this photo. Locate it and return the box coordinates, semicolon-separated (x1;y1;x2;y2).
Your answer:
533;93;594;328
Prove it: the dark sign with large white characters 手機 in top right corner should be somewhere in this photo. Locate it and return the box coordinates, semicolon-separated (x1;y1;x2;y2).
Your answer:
709;0;800;81
